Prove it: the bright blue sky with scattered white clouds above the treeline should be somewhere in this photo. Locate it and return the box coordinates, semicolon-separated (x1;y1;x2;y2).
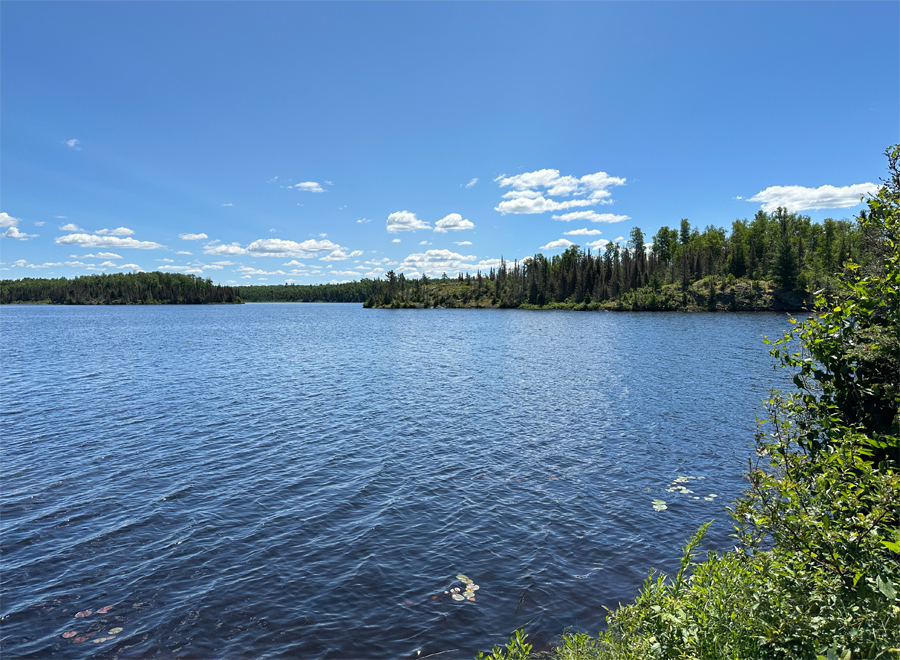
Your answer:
0;1;900;285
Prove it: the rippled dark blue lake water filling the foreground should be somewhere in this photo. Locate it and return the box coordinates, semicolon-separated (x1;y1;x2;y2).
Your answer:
0;304;789;660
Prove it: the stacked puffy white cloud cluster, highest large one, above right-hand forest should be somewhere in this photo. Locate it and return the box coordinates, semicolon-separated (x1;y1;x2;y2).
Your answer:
494;169;625;215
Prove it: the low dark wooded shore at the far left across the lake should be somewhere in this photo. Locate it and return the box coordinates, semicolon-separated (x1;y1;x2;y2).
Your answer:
0;272;241;305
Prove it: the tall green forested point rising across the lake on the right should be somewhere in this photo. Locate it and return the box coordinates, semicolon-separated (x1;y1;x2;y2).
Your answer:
366;209;864;309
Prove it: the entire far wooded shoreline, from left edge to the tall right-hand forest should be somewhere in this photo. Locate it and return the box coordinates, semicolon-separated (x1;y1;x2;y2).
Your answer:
0;214;868;311
